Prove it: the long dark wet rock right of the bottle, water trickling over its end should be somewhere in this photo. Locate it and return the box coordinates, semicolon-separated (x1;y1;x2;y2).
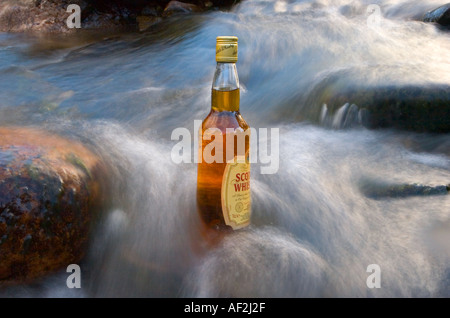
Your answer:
305;78;450;133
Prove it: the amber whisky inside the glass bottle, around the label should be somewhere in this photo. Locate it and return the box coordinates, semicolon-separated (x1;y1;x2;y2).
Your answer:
197;89;250;230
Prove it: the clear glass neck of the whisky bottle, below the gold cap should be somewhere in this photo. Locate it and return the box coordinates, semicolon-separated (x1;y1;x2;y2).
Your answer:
211;62;240;111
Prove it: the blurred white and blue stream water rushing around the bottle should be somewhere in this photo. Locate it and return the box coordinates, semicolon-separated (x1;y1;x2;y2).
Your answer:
0;0;450;297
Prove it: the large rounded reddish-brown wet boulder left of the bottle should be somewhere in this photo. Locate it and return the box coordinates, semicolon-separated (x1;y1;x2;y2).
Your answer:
0;128;104;286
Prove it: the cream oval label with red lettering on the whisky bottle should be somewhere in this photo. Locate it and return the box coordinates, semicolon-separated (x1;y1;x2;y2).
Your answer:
221;155;251;229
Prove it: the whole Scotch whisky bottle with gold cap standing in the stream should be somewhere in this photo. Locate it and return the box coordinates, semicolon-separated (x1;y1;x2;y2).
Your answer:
197;36;251;230
